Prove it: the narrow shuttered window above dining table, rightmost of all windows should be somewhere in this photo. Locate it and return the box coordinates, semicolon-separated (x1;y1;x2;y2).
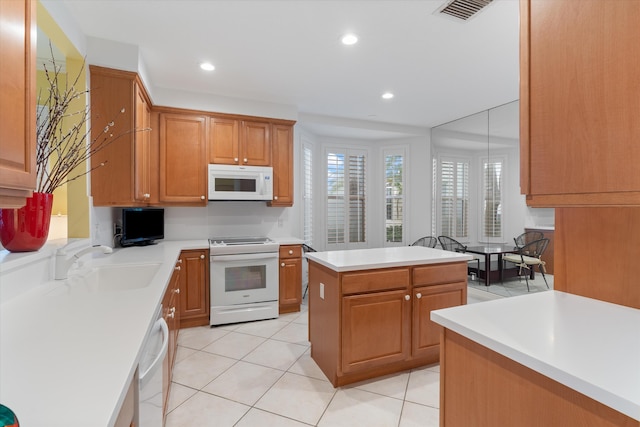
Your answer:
481;158;504;238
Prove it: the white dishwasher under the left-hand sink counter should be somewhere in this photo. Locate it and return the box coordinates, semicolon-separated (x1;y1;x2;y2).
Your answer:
138;305;169;427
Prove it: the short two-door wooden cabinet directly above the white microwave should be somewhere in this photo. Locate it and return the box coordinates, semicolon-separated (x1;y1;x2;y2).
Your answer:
209;117;271;166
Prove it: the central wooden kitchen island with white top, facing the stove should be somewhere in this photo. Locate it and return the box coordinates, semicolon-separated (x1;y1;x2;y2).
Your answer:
306;246;471;387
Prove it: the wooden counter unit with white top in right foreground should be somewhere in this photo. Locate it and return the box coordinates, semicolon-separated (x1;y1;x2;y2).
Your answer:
431;291;640;426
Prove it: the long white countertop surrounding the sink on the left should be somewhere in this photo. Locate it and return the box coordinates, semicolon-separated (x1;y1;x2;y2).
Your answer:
0;240;208;427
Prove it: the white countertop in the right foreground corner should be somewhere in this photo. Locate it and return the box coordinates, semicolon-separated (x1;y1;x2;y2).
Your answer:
431;291;640;420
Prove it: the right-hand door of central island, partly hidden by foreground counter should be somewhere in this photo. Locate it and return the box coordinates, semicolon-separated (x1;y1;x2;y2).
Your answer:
411;282;467;357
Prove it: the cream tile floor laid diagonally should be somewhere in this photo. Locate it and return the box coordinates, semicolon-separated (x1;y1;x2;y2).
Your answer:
166;276;553;427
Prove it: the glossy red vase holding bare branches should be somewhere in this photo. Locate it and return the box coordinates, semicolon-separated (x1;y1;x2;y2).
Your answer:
0;193;53;252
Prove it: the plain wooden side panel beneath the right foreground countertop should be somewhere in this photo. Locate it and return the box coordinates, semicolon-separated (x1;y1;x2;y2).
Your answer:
440;329;640;427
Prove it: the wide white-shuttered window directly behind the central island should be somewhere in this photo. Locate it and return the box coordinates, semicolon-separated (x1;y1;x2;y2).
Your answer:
327;150;367;247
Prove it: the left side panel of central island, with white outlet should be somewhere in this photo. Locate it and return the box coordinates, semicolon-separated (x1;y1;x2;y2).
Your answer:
309;259;341;385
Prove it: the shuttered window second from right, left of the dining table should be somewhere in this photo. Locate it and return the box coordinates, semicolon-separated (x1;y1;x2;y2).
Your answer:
439;158;469;240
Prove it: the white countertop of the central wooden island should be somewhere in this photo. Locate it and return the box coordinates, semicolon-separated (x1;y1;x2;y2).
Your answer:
305;246;472;272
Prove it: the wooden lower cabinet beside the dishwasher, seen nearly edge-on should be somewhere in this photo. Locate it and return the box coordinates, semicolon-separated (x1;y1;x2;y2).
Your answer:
162;262;181;422
